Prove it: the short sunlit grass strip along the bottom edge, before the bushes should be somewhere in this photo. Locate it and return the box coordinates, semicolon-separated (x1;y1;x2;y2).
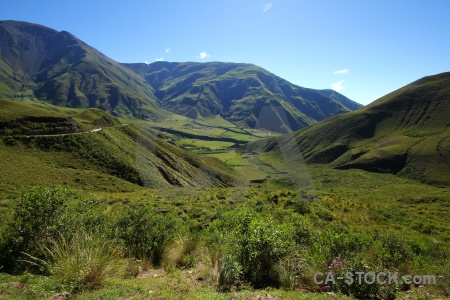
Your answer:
0;269;358;300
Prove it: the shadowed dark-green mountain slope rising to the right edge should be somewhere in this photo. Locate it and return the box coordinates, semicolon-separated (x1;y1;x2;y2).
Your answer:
249;73;450;186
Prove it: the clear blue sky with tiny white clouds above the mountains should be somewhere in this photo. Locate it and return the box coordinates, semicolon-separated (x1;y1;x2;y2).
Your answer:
0;0;450;104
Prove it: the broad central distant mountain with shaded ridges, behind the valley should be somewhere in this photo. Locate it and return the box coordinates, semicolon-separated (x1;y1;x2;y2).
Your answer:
123;62;361;133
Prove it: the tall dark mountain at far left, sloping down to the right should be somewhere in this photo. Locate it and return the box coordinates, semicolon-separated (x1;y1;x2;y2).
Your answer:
0;21;164;118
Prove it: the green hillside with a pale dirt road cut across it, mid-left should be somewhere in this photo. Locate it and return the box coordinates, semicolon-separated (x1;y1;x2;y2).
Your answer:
0;100;234;190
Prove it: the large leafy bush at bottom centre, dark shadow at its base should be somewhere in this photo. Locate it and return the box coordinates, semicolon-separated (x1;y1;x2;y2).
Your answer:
206;212;293;286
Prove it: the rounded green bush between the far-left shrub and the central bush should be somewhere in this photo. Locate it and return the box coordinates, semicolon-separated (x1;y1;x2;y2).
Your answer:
113;206;180;264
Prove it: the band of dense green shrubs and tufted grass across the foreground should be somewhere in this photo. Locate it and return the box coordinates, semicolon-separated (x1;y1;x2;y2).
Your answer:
0;182;450;299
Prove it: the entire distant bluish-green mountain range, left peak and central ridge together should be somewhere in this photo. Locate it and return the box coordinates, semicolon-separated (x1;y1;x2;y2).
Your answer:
0;21;361;133
